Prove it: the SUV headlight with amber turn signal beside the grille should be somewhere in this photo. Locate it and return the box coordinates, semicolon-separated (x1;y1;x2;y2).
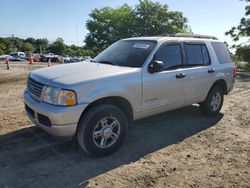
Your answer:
42;86;76;106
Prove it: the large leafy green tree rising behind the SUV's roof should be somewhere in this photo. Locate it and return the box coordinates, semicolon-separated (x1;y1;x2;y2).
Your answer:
85;0;190;53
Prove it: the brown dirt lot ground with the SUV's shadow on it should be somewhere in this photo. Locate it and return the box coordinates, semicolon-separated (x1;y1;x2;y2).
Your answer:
0;62;250;188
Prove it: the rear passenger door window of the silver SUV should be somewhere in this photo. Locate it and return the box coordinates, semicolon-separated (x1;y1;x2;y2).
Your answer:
185;44;210;66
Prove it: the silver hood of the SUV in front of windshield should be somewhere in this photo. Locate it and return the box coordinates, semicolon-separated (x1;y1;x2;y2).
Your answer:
30;62;139;85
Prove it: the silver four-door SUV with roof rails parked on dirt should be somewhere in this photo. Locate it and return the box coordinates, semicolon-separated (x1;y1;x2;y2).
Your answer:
24;34;235;156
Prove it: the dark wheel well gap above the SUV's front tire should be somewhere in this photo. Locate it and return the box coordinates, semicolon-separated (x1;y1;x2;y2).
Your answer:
82;97;134;122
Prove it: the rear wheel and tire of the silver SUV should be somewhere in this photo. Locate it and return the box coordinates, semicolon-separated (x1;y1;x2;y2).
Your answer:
200;86;224;116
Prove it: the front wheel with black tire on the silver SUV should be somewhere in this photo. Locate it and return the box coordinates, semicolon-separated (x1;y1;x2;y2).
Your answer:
77;104;128;157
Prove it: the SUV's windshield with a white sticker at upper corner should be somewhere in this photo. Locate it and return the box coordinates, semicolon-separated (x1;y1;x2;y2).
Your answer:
94;40;156;67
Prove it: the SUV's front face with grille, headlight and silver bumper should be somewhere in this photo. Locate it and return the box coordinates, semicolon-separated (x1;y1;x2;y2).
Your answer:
24;76;87;137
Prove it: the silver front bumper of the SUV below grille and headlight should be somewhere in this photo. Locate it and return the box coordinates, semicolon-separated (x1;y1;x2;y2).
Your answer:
24;91;88;137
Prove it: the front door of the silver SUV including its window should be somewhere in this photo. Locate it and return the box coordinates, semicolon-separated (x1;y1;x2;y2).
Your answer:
142;43;186;115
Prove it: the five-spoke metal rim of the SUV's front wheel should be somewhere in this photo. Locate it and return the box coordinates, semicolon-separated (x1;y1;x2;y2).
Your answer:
93;117;121;149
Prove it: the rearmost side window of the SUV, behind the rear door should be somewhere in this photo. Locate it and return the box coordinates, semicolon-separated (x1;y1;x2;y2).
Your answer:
211;42;232;64
